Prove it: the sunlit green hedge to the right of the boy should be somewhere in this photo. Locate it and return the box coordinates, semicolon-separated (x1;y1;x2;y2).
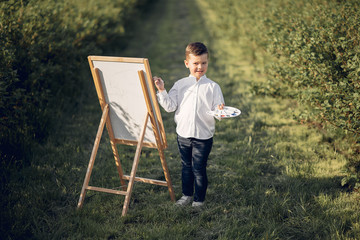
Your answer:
202;0;360;186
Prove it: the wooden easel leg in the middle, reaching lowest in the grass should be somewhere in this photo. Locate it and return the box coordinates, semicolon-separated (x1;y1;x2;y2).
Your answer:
122;113;149;216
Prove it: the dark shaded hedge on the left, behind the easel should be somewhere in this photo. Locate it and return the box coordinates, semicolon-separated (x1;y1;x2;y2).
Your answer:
0;0;145;165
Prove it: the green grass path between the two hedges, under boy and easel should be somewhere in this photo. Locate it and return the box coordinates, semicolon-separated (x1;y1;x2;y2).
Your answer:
1;0;360;239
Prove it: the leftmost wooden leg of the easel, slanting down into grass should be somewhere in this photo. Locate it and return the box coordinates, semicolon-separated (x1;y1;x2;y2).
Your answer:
77;104;109;208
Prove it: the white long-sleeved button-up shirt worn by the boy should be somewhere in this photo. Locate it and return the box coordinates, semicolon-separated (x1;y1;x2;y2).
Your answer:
157;75;225;139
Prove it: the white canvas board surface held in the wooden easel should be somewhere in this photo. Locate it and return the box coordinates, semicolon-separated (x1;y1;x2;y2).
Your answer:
93;61;158;144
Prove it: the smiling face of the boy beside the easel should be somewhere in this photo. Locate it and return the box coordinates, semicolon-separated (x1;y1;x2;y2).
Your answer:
184;53;208;80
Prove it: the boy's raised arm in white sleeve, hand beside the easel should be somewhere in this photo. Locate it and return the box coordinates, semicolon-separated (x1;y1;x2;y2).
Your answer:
153;77;177;112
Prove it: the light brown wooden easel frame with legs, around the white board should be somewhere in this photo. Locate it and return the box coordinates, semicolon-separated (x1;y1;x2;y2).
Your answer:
78;56;175;216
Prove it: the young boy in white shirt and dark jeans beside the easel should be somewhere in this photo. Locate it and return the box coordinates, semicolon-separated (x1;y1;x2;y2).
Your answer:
154;42;224;207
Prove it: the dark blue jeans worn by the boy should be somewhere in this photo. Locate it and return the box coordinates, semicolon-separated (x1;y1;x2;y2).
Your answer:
177;135;213;202
